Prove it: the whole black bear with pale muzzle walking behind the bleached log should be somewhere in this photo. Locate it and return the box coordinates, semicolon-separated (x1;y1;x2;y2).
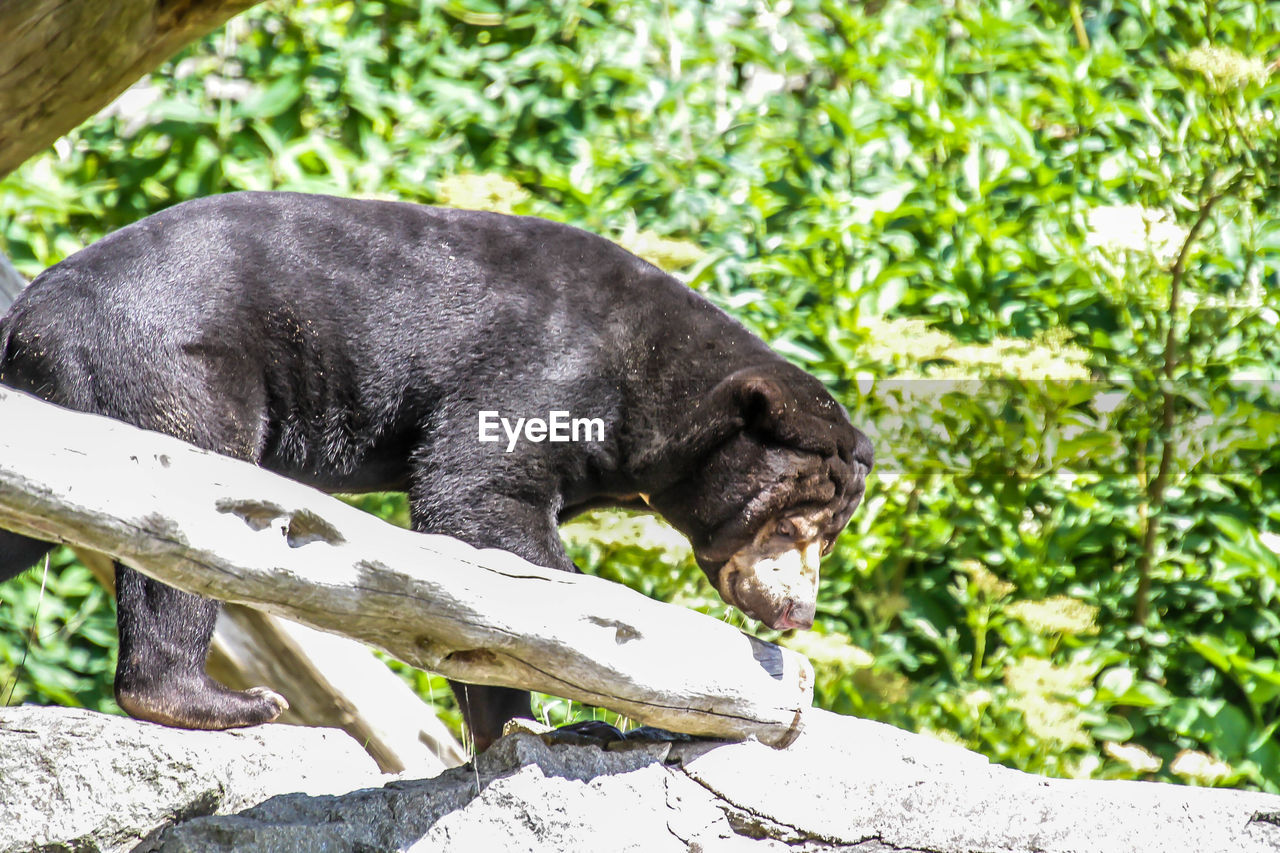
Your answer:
0;192;872;749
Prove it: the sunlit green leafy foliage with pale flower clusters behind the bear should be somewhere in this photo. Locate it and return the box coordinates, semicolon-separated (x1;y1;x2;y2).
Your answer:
0;0;1280;792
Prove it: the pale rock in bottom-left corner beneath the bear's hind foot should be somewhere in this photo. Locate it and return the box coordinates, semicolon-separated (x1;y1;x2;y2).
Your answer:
0;706;385;853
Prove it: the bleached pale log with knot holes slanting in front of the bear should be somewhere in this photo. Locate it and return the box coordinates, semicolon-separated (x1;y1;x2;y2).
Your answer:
0;388;813;745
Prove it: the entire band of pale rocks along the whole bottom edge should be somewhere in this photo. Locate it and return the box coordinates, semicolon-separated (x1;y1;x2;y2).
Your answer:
0;708;1280;853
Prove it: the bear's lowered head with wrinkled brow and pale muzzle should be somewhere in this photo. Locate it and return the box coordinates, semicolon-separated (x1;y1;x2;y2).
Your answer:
649;362;873;629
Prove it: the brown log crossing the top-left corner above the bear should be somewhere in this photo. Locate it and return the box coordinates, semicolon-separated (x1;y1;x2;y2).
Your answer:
0;0;257;178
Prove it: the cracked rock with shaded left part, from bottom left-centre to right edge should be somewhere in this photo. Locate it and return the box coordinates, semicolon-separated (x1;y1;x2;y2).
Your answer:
147;712;1280;853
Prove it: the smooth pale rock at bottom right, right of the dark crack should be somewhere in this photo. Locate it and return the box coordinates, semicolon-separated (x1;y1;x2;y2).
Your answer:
682;712;1280;853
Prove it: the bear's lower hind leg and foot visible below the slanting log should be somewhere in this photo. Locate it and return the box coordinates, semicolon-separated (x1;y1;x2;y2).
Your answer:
115;564;289;729
